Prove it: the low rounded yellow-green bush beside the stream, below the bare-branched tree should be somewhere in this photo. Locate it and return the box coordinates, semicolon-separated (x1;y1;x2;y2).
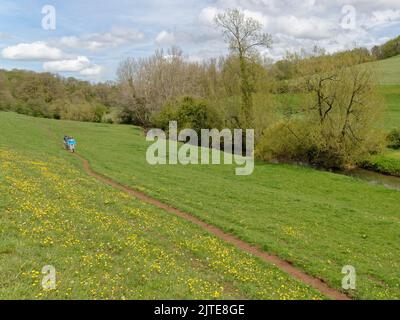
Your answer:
256;118;381;169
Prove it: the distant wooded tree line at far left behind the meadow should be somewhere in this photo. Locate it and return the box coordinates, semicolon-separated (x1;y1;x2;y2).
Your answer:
0;70;119;122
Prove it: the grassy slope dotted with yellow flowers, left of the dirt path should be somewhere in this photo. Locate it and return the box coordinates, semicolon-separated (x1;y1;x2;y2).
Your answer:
0;113;323;299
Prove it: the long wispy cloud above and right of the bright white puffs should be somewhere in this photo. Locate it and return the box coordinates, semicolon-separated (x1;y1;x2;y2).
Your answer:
59;28;145;51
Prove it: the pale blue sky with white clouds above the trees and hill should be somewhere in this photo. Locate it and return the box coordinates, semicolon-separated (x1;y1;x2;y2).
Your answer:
0;0;400;81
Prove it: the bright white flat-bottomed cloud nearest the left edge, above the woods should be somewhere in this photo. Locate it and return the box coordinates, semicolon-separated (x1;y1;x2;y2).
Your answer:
2;41;63;61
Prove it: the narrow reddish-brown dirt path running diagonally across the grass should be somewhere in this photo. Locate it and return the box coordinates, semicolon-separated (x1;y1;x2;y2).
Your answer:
75;154;350;300
